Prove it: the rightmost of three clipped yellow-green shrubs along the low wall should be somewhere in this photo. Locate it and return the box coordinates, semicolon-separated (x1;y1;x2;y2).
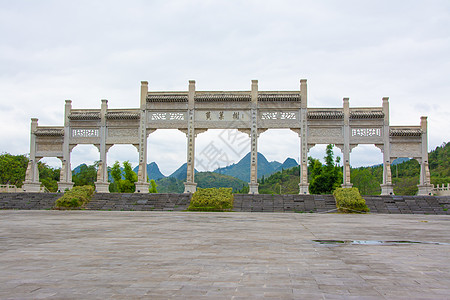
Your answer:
333;188;369;213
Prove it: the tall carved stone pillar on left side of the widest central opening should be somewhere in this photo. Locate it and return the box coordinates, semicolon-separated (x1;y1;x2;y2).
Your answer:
184;80;197;193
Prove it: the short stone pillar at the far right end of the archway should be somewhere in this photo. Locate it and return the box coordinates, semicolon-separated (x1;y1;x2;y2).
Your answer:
417;117;433;196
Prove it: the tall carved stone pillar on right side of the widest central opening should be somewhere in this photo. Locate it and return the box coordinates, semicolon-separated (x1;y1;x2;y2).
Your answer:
248;80;259;194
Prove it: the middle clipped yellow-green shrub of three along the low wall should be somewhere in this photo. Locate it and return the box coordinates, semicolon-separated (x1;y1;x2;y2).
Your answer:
188;188;234;211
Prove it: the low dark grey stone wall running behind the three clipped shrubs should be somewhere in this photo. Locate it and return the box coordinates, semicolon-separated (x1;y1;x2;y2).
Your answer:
0;193;450;215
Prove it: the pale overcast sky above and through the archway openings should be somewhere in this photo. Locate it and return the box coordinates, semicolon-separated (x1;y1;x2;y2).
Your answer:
0;0;450;175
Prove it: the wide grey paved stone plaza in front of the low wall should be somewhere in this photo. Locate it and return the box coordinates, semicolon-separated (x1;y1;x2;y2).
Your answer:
0;210;450;299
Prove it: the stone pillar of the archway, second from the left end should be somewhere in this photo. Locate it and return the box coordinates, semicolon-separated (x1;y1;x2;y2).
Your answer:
58;100;73;193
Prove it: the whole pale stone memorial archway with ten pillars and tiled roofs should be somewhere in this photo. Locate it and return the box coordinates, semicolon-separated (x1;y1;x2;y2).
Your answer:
24;79;432;195
